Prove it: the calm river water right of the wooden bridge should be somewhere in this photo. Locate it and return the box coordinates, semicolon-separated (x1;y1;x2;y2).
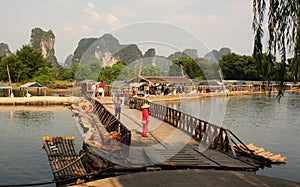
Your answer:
165;93;300;182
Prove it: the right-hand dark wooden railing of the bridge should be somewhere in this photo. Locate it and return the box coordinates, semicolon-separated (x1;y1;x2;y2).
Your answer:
130;98;254;157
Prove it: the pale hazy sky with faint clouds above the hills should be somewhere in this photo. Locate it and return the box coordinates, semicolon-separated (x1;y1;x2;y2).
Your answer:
0;0;253;63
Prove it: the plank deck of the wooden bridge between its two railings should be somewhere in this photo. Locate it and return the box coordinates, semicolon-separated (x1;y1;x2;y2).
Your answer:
97;99;260;171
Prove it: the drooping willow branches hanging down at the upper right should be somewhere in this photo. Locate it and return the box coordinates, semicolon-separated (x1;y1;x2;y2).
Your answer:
252;0;300;95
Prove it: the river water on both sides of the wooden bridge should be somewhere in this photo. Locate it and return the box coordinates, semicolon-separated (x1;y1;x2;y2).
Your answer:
0;93;300;186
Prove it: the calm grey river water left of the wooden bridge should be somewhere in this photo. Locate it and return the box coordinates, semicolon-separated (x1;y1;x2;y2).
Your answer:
0;106;82;186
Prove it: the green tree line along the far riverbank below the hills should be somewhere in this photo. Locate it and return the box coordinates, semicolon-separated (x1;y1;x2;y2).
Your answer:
0;45;294;85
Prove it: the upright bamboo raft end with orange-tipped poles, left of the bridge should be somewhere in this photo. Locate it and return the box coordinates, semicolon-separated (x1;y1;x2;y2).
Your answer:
43;136;87;184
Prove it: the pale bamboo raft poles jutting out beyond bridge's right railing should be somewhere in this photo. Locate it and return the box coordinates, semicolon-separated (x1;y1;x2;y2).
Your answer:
235;143;286;164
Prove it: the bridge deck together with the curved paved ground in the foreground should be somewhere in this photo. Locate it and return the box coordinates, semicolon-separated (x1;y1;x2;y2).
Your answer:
70;99;300;187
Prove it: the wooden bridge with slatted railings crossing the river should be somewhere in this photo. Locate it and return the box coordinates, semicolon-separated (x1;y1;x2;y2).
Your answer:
43;98;271;186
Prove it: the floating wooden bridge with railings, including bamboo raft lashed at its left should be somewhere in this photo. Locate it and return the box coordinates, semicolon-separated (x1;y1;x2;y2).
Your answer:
43;98;286;186
